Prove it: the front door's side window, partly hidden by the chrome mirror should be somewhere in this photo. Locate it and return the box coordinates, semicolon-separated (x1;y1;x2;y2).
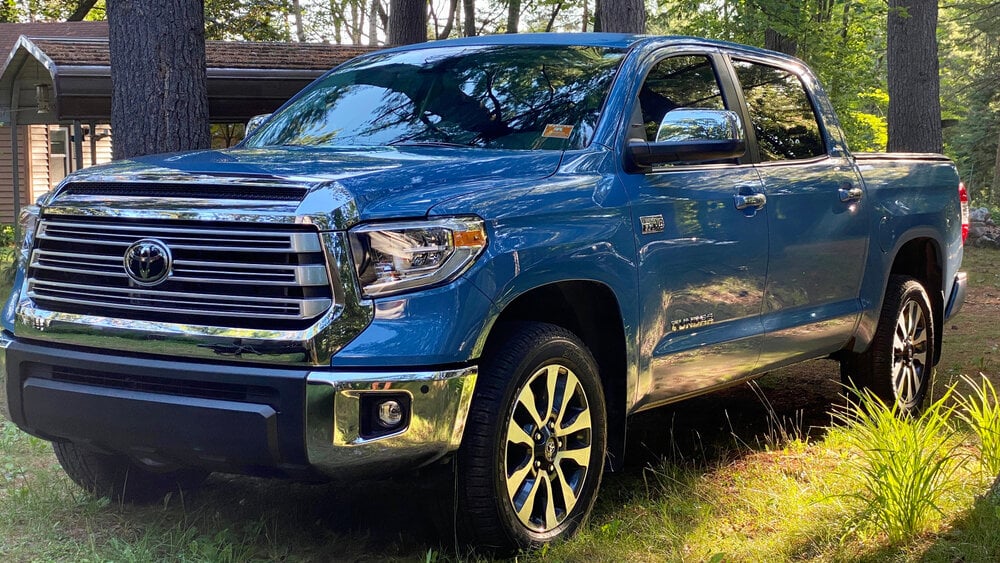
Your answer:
629;55;725;141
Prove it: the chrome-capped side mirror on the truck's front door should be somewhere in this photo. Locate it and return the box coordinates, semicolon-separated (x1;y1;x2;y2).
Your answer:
628;108;746;171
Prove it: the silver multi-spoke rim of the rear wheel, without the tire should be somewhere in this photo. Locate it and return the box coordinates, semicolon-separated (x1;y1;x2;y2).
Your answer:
892;300;931;410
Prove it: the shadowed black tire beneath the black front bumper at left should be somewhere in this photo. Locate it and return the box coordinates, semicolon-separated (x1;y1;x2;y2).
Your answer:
52;442;209;503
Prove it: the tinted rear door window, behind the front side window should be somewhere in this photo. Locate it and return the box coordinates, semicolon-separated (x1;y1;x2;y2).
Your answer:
733;60;826;161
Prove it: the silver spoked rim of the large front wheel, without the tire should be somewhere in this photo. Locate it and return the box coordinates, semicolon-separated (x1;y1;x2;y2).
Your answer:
501;364;592;532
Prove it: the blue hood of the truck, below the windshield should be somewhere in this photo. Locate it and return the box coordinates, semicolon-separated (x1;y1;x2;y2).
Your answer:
51;147;562;228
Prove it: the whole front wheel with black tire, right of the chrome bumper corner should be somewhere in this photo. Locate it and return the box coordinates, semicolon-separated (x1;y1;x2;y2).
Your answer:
456;323;607;554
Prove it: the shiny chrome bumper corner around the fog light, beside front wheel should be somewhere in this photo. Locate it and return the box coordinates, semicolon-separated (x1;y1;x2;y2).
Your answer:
306;366;478;477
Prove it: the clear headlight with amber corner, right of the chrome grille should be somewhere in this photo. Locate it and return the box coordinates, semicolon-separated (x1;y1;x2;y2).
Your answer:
350;217;486;297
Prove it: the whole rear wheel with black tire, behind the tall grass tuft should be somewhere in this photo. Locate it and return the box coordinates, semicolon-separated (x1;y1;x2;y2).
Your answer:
841;276;935;416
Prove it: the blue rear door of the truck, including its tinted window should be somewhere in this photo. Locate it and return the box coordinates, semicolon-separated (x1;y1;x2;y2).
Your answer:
732;55;870;370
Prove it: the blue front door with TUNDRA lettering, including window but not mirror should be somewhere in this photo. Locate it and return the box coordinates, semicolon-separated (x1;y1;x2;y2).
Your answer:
622;51;768;408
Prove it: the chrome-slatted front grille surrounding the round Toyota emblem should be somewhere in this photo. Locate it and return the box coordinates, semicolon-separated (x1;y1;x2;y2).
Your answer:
28;217;333;329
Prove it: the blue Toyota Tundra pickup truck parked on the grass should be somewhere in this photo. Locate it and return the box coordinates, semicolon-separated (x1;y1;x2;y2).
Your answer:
0;34;967;550
